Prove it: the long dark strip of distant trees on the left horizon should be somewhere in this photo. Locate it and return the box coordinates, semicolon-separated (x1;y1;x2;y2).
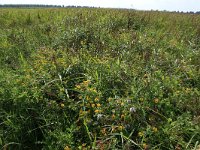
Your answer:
0;4;93;8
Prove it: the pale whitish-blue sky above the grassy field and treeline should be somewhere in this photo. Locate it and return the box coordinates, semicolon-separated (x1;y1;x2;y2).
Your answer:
0;0;200;11
